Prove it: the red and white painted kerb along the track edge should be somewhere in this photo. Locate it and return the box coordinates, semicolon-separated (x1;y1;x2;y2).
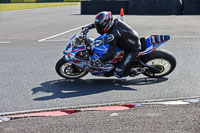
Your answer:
0;99;200;123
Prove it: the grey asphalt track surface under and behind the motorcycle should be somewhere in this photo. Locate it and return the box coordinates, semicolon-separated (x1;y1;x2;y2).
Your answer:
0;6;200;113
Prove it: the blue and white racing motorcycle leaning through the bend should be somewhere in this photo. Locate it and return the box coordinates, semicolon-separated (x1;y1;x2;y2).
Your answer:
55;31;176;79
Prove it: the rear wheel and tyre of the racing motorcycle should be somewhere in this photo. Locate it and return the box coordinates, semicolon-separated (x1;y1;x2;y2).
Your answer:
142;49;176;78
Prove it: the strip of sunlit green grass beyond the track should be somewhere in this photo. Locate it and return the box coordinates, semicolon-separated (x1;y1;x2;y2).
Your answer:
0;2;80;11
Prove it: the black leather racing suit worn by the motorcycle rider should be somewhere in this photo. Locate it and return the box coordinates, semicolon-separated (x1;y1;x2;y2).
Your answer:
88;19;141;77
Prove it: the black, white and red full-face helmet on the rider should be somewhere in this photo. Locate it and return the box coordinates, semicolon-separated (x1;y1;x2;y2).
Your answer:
94;11;114;34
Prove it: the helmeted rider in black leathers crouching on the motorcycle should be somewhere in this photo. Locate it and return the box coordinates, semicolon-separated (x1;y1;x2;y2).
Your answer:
83;11;141;78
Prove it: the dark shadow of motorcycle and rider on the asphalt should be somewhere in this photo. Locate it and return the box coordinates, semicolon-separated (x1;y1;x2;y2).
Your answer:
32;78;168;101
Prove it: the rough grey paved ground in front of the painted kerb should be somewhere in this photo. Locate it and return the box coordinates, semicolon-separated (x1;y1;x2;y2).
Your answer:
0;103;200;133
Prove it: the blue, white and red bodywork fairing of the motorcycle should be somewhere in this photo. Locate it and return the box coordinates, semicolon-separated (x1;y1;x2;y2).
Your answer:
64;33;170;76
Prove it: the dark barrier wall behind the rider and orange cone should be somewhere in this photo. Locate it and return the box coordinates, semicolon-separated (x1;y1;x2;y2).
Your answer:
81;0;200;15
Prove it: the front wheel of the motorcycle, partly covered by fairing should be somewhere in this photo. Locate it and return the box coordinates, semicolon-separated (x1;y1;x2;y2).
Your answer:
55;58;88;79
